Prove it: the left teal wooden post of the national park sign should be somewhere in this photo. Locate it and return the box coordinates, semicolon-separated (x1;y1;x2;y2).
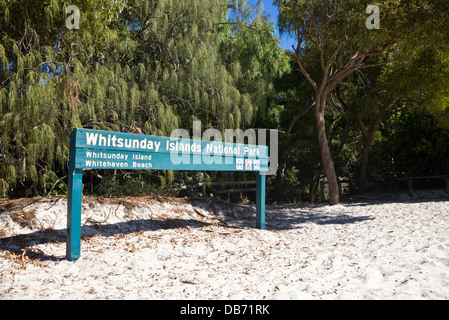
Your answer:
66;129;83;261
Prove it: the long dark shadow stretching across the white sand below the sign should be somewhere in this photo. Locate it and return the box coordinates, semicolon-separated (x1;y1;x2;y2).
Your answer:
0;201;384;261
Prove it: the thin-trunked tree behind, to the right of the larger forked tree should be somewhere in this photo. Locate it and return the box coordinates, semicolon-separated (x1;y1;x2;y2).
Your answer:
336;46;449;192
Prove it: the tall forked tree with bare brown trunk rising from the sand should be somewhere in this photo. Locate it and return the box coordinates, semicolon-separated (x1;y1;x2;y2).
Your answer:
275;0;448;205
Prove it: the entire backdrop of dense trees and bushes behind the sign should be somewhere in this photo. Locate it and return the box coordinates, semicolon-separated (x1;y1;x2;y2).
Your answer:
0;0;449;204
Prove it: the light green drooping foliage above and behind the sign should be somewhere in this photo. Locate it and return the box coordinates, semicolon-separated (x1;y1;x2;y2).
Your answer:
0;0;285;199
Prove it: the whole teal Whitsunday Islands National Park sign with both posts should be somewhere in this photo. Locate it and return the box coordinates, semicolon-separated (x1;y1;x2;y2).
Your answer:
66;129;268;261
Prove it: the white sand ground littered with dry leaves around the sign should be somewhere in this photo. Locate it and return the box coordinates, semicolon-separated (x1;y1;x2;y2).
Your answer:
0;190;449;300
